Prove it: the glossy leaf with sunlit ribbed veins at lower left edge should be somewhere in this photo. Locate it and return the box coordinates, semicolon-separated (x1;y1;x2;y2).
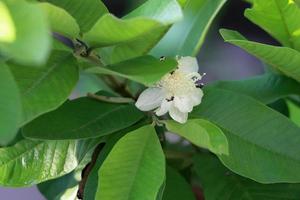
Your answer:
0;140;99;187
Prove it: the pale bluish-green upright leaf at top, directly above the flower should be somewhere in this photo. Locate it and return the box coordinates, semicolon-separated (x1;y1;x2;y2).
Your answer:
152;0;226;56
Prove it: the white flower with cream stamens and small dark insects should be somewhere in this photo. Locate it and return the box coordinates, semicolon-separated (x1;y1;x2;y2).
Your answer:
135;57;203;123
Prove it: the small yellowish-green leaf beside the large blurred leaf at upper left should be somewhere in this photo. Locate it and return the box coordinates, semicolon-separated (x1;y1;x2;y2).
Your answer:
39;3;80;38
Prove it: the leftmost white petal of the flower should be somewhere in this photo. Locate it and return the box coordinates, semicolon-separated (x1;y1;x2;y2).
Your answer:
135;87;165;111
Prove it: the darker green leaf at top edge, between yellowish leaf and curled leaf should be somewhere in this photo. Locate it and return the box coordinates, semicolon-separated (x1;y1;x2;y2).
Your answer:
46;0;108;33
